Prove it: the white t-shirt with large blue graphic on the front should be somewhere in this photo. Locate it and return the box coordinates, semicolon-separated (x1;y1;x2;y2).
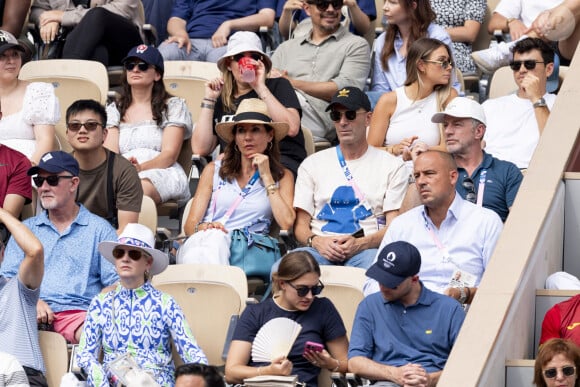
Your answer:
294;146;409;235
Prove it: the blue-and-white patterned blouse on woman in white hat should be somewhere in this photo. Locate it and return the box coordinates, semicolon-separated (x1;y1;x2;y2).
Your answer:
77;282;207;386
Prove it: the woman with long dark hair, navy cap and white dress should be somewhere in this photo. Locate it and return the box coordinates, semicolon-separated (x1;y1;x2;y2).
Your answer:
105;45;192;203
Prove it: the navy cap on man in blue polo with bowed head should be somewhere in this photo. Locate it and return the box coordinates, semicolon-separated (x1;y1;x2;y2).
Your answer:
366;241;421;289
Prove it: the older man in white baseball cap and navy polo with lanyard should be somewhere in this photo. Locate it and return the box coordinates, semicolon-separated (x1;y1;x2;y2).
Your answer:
431;97;523;222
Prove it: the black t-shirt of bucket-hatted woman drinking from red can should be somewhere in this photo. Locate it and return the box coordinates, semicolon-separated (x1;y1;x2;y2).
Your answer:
213;78;306;179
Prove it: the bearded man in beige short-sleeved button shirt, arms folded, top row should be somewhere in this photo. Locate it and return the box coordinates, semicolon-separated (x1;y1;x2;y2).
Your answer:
271;0;370;142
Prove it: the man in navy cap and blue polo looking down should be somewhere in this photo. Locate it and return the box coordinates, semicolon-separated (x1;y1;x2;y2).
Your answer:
348;241;465;387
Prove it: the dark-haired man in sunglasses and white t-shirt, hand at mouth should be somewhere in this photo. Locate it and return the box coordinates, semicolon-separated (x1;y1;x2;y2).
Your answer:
483;38;556;169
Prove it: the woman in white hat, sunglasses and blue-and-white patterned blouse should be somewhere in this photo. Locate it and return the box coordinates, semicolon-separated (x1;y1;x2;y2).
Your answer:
77;223;207;386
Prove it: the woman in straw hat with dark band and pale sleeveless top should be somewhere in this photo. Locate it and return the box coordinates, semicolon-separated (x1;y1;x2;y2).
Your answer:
178;98;296;272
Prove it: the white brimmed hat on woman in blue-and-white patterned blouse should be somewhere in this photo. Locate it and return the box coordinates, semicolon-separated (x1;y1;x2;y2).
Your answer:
99;223;169;275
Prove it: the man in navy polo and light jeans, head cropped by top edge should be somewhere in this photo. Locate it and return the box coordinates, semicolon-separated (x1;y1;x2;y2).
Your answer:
159;0;276;62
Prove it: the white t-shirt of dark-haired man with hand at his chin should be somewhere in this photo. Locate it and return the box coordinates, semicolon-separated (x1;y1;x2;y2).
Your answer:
482;93;556;168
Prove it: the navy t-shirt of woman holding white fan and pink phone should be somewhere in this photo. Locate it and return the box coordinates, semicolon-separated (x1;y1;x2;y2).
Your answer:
233;297;346;386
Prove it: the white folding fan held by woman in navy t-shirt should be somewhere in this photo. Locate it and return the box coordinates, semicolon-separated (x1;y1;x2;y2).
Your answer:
252;317;302;363
